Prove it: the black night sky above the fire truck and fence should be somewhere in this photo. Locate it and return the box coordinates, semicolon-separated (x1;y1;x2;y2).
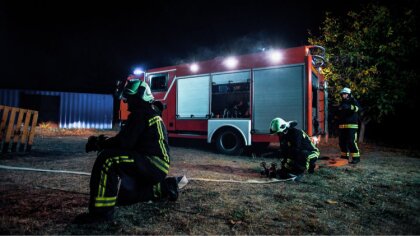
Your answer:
0;0;368;93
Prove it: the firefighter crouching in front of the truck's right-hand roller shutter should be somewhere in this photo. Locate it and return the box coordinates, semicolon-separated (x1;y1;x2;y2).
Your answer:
270;118;320;179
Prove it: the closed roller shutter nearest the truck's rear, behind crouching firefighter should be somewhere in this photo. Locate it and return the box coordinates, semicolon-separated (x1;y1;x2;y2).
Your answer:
252;64;305;134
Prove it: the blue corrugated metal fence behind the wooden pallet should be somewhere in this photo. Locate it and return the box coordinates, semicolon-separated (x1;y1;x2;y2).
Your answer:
0;89;113;129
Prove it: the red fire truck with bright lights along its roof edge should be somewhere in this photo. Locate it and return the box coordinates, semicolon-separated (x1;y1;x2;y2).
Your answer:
119;46;328;155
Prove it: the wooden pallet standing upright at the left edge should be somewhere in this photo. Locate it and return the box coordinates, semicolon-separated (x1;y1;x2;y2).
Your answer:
0;105;38;153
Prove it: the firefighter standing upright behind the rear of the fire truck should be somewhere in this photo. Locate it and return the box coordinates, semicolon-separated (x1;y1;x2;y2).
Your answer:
338;88;360;164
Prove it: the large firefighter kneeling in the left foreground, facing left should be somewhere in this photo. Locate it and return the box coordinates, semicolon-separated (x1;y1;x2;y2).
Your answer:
74;79;179;224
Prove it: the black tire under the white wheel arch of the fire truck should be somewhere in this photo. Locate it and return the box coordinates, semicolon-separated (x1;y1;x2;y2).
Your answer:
215;129;245;155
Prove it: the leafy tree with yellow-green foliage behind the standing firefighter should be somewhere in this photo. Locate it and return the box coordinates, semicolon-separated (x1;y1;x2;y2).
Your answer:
308;0;418;142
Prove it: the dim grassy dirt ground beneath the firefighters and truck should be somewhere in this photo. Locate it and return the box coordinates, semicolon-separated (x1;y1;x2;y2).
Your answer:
0;135;420;235
